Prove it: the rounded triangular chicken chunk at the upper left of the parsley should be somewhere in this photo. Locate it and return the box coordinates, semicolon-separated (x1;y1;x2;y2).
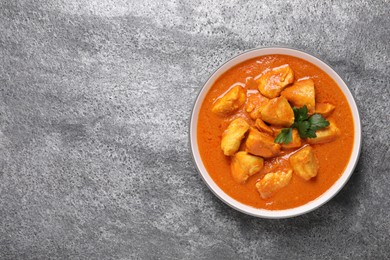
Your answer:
261;97;294;127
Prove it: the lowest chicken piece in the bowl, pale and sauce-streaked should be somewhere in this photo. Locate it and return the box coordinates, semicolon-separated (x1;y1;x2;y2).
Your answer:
256;170;292;199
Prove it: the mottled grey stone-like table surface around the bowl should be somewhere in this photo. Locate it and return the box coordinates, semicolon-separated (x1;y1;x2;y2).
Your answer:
0;0;390;259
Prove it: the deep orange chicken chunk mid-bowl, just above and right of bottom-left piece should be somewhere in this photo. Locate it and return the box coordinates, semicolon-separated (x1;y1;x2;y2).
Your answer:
245;127;280;158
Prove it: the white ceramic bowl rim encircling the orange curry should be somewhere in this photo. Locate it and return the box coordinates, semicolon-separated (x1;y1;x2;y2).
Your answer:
190;48;361;219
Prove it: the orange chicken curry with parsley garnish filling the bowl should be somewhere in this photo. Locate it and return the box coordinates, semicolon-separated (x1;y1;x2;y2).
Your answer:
197;55;354;210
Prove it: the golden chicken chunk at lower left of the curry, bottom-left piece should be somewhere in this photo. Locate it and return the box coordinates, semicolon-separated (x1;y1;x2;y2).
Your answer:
230;151;264;183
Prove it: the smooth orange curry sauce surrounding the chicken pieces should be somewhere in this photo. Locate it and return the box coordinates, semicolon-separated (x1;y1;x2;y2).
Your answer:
197;55;354;210
